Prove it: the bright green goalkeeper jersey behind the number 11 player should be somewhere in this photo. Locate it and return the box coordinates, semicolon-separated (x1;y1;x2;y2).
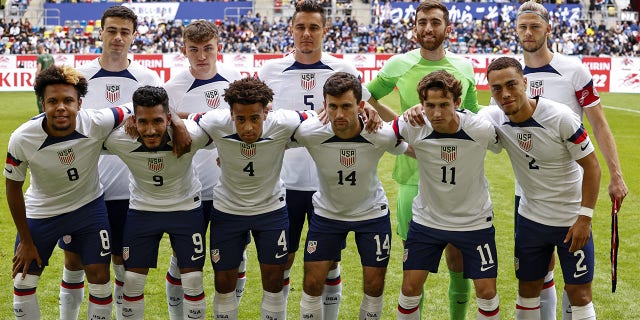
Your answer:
367;49;478;185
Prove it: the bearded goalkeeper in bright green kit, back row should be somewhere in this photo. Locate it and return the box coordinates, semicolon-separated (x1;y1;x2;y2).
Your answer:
367;0;478;320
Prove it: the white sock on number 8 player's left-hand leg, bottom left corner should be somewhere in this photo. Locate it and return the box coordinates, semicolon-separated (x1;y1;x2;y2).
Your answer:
13;273;40;320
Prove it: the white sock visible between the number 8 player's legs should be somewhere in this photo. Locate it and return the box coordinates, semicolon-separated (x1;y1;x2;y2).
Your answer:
58;268;84;319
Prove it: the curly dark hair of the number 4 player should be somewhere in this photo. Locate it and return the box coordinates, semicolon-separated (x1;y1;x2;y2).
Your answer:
224;78;273;108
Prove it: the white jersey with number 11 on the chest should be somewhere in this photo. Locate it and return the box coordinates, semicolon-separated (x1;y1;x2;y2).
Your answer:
394;110;501;231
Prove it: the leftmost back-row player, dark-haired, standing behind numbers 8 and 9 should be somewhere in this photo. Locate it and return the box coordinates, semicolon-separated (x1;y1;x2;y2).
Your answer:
59;6;189;319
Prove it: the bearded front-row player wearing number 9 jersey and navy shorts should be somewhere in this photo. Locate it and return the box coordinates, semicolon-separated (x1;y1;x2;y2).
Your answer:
104;86;211;319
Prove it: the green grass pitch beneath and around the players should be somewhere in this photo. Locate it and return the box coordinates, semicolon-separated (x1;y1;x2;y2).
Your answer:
0;92;640;319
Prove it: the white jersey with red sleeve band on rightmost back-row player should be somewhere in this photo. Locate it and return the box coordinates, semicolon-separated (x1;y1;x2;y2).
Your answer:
524;52;600;119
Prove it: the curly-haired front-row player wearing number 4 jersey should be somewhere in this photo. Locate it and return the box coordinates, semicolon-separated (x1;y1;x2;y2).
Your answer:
194;78;315;320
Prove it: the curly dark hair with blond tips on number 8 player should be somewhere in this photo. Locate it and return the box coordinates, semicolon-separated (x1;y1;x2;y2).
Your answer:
33;65;89;100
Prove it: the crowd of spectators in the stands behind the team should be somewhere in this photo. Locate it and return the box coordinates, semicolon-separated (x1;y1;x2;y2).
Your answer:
0;9;640;56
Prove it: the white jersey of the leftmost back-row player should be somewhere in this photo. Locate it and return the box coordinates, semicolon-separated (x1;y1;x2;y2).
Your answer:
78;59;162;200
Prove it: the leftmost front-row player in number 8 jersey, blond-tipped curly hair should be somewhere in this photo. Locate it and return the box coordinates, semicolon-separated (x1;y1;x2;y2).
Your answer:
4;66;131;319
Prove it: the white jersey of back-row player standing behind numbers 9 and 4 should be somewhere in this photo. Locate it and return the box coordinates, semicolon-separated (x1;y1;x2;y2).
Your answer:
164;62;242;200
